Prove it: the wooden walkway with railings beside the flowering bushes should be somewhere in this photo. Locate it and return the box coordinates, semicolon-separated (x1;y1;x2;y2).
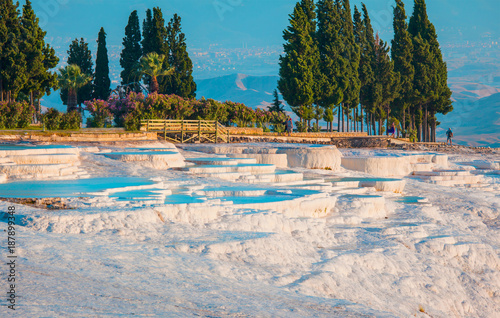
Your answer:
141;119;230;143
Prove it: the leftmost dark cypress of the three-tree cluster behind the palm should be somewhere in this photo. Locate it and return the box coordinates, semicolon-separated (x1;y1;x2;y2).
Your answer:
120;10;142;92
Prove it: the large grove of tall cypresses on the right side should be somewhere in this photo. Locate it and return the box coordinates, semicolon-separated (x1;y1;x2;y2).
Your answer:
278;0;453;141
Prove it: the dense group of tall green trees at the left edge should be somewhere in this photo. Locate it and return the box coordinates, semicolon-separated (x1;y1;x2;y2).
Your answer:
0;0;59;112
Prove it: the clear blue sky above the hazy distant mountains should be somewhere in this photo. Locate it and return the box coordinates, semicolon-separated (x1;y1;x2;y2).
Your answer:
33;0;500;48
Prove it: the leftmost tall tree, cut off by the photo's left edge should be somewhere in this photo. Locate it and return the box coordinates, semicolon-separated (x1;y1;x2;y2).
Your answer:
0;0;27;100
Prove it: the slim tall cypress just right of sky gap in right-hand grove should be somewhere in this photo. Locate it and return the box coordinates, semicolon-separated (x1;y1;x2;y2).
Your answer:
391;0;415;135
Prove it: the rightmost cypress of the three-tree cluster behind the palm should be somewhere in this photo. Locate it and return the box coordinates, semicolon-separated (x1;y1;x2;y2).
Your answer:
160;14;196;98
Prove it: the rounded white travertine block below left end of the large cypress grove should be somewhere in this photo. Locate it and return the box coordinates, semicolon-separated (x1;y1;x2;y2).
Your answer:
278;146;342;171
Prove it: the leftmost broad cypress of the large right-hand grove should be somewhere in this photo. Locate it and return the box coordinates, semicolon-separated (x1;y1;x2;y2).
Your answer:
278;0;318;126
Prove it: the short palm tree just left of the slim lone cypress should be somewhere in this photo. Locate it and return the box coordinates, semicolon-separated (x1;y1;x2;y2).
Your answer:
57;64;91;113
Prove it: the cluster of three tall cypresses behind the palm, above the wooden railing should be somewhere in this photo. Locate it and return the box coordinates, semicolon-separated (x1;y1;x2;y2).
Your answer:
120;8;196;98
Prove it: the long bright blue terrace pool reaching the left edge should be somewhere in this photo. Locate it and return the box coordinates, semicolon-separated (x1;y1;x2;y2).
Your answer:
0;177;156;198
